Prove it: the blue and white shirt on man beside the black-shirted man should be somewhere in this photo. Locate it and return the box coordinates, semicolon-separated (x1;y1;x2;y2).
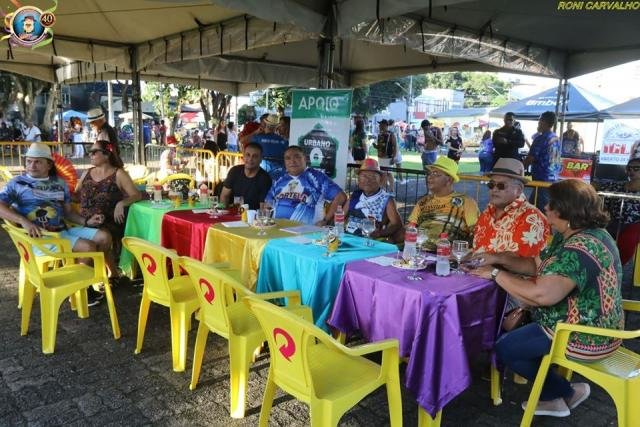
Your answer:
266;168;342;224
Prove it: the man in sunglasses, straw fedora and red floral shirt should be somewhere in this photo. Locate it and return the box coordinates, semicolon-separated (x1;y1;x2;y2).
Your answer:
473;159;551;257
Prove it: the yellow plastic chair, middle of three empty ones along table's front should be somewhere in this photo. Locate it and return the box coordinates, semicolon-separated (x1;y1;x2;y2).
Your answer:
180;257;312;418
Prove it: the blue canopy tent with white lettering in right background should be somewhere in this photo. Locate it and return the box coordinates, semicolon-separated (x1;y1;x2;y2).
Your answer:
489;83;613;122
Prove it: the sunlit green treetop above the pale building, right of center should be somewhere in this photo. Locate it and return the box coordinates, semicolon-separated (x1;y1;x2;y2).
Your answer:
426;71;511;107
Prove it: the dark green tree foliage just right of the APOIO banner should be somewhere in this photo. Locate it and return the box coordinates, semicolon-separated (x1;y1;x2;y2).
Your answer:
352;75;427;116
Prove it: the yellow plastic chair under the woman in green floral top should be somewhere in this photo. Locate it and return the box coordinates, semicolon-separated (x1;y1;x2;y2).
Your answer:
520;300;640;426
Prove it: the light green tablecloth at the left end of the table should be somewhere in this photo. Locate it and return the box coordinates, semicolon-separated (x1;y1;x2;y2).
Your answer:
118;200;201;277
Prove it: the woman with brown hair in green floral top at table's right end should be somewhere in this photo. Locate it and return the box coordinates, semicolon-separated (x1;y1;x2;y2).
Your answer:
464;179;624;417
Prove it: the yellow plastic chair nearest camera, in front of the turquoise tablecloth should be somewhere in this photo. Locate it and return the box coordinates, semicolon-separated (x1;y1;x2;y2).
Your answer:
244;297;402;427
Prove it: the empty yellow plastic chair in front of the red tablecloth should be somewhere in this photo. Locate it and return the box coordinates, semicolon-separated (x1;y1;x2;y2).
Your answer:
122;237;198;372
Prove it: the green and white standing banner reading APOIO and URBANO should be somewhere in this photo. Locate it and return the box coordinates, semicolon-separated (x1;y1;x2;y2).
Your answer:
289;89;353;188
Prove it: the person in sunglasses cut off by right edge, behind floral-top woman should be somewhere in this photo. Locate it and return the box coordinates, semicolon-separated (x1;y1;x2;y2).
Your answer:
596;158;640;264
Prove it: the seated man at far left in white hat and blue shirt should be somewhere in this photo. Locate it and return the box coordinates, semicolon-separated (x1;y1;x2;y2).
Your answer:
0;143;111;305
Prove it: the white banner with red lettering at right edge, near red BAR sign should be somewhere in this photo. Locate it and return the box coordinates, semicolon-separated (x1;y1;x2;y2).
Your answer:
599;119;640;165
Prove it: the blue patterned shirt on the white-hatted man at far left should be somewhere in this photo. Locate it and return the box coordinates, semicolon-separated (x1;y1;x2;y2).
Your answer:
0;175;71;231
